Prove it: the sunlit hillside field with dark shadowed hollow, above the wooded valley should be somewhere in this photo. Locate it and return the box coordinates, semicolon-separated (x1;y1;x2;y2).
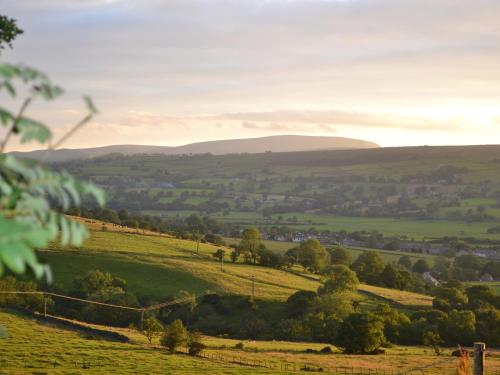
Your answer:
40;231;431;306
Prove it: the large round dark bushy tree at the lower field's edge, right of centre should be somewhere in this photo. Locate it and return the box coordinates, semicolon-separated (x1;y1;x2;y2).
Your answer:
337;312;385;354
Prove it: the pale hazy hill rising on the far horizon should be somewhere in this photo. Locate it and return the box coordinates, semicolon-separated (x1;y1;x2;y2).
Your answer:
12;135;379;162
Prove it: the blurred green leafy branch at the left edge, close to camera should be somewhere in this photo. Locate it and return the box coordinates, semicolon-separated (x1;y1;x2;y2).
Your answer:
0;64;104;282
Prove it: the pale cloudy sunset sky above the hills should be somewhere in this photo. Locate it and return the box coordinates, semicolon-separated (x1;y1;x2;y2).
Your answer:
0;0;500;150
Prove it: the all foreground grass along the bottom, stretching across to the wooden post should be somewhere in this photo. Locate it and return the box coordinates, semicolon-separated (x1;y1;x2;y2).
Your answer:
0;310;500;375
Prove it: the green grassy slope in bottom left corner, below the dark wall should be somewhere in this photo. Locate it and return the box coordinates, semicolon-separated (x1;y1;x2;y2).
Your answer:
0;311;270;375
